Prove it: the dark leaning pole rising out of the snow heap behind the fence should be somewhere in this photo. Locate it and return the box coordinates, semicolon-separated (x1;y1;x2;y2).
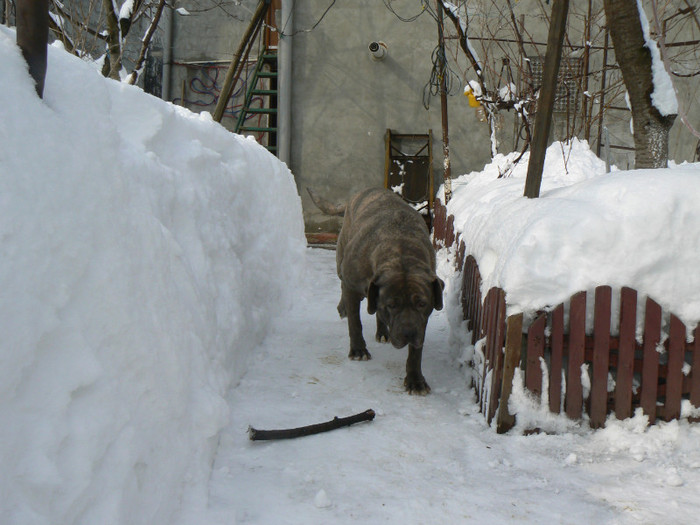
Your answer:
525;0;569;198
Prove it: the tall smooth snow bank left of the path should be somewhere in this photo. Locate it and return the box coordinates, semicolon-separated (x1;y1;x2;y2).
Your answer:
0;27;305;524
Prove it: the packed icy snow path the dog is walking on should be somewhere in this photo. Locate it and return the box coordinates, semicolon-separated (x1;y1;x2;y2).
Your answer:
209;249;700;525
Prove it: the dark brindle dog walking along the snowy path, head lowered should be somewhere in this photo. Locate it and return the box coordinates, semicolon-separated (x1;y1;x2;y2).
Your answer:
336;189;444;394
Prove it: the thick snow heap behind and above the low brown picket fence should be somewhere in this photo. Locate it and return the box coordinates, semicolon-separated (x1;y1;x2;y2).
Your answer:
447;140;700;328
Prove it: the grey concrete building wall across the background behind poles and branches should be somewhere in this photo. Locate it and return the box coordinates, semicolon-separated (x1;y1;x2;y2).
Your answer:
169;0;700;232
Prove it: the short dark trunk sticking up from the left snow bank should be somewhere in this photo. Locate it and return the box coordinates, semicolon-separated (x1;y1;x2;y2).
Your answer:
17;0;49;98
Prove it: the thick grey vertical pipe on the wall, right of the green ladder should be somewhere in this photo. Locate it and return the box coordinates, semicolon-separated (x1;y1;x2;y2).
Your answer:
277;0;294;166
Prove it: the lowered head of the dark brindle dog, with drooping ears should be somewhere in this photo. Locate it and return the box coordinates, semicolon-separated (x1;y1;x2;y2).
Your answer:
367;272;445;348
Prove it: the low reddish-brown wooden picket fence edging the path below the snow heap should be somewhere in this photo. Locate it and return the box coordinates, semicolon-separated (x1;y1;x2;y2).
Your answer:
434;202;700;432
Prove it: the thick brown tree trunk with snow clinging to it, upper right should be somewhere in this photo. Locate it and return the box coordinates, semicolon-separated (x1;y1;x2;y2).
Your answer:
604;0;676;169
